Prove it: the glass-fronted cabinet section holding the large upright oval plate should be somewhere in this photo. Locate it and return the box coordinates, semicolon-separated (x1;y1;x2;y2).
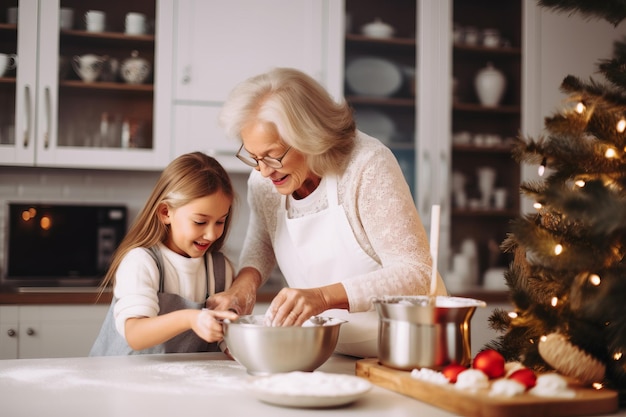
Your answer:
344;0;417;191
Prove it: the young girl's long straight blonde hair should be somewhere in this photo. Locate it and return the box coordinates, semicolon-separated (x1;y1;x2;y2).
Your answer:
101;152;235;291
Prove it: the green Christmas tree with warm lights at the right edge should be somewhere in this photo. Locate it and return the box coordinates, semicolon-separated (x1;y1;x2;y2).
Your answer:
487;0;626;403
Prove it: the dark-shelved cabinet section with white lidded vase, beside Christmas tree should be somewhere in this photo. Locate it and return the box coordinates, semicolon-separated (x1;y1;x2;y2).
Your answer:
450;0;523;285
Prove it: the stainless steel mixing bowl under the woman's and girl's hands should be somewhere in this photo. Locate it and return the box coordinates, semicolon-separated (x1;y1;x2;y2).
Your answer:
223;315;345;375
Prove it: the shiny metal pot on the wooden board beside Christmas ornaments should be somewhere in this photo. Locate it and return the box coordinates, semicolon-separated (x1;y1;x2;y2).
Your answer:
374;296;487;370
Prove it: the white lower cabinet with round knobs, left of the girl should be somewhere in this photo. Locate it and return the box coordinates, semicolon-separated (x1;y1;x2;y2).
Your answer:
0;305;109;359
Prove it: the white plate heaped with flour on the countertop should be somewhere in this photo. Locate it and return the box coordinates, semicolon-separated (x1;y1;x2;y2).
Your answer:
248;372;372;408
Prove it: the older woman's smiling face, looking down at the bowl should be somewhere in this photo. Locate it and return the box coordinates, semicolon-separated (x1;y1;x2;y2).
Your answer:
241;121;312;195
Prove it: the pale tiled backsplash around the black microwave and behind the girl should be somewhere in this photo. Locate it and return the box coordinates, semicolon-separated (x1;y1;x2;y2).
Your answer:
0;166;262;284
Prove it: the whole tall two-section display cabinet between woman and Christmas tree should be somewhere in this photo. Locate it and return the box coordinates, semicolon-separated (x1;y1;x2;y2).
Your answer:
344;0;522;292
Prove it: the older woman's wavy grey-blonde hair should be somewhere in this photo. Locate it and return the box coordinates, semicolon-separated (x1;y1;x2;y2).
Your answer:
219;68;356;176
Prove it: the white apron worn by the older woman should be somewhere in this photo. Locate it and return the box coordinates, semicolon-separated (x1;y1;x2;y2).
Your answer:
274;177;381;357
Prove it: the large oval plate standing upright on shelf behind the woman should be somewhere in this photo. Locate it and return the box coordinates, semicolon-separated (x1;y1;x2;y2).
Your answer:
346;57;402;97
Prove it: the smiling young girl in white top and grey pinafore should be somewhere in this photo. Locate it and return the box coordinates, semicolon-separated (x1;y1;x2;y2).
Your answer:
90;152;237;356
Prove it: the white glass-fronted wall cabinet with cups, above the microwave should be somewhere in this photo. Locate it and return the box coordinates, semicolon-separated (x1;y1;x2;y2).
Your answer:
0;0;173;169
